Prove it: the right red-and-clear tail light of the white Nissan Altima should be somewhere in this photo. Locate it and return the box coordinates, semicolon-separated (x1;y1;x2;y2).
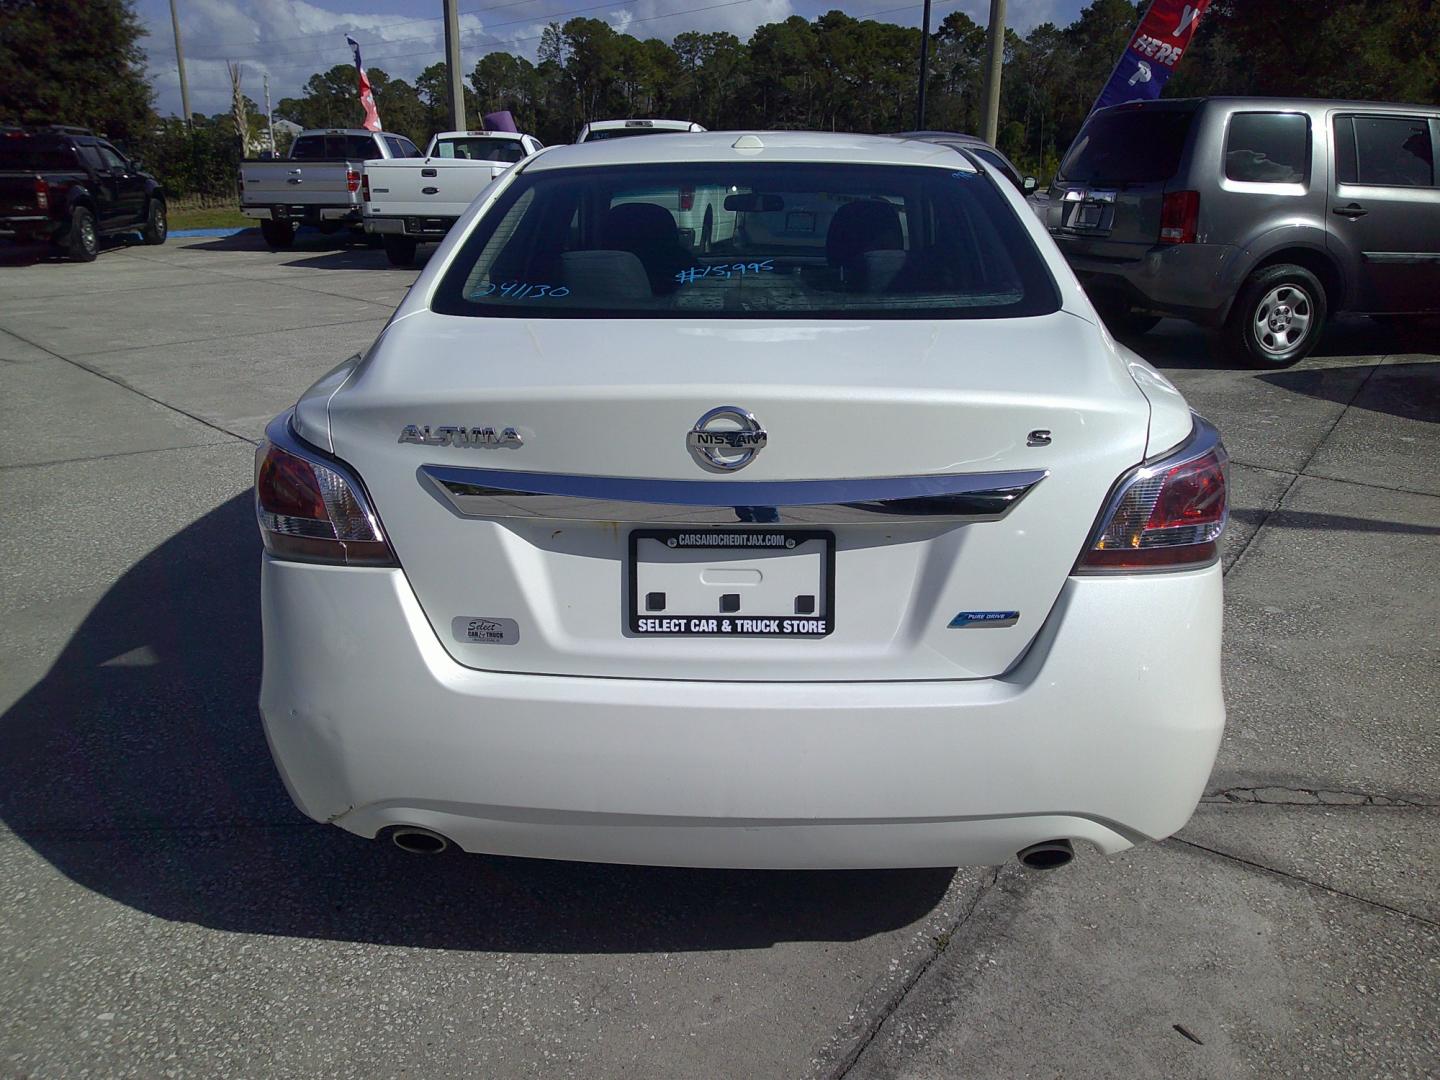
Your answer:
1076;416;1230;573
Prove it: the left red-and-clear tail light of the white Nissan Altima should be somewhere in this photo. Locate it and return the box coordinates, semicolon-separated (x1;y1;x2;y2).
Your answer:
255;415;396;566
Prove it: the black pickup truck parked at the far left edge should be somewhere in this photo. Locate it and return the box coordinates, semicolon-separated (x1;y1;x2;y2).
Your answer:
0;125;166;262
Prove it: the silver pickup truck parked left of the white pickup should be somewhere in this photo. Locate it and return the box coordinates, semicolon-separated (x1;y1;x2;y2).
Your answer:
240;128;420;248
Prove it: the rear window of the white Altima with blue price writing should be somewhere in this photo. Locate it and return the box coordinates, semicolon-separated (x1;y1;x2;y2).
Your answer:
433;163;1060;318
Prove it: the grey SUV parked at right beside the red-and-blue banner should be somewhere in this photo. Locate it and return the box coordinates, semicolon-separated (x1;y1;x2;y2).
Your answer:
1045;98;1440;367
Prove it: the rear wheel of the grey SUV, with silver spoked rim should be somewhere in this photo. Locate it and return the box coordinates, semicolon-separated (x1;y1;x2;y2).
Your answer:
1225;264;1329;370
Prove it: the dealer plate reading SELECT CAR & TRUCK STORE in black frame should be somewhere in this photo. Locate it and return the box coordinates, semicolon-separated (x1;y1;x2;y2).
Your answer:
628;528;835;638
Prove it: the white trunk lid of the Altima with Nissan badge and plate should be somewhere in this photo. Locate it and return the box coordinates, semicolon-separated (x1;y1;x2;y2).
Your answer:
330;311;1149;680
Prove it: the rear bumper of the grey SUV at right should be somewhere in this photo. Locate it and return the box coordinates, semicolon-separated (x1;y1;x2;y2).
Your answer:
1056;233;1241;325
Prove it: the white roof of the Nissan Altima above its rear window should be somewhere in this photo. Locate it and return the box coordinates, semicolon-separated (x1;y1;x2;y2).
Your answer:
526;131;975;171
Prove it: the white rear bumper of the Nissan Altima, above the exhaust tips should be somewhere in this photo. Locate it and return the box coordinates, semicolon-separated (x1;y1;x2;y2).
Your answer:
261;557;1224;867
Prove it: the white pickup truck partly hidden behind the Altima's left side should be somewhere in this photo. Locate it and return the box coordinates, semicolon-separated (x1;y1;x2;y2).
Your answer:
360;131;543;266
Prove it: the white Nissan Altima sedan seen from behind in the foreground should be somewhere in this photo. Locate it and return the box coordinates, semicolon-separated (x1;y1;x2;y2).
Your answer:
255;132;1225;867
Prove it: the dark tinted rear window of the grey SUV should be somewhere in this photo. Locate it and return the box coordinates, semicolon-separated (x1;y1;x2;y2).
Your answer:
1056;109;1195;184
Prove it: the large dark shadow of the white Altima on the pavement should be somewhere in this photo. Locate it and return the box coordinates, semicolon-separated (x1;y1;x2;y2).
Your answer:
0;492;953;952
